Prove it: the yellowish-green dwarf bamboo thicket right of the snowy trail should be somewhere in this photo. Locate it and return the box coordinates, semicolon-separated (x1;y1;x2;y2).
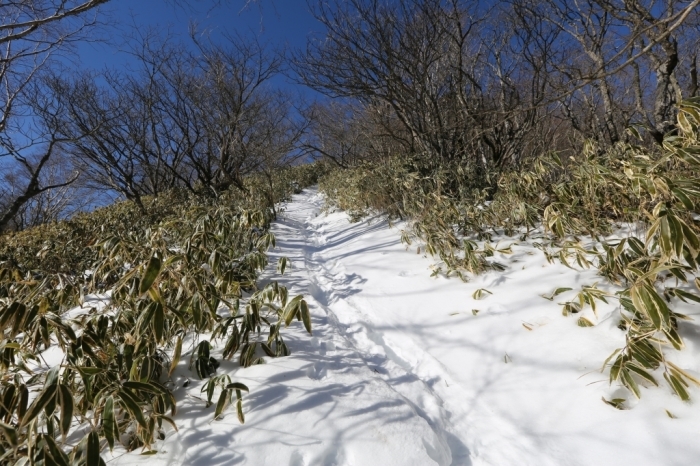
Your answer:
320;98;700;409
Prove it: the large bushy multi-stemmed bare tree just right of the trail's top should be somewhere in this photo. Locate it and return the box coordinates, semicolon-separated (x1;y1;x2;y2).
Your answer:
294;0;550;178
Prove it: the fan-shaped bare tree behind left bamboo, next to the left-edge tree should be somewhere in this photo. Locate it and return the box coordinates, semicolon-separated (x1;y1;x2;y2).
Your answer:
39;73;176;209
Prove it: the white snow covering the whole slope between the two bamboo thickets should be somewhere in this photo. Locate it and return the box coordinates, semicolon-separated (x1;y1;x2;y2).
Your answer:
104;189;700;466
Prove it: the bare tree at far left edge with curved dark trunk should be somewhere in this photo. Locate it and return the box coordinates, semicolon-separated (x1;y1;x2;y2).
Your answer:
0;0;107;230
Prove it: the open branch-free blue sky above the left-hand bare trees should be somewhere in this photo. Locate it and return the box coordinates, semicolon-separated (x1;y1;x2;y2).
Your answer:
74;0;323;97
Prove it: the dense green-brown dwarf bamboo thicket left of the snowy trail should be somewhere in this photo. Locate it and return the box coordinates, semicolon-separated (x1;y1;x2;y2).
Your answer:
0;164;321;466
